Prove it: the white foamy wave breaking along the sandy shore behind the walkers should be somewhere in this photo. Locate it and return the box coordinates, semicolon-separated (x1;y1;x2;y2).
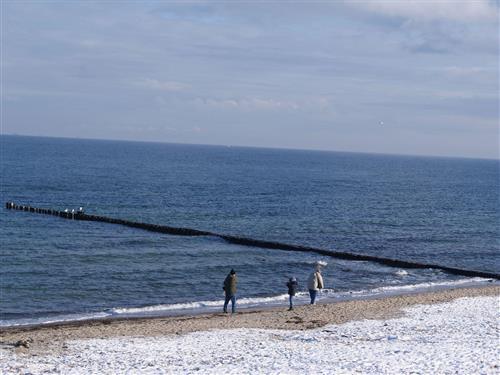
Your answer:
0;277;494;328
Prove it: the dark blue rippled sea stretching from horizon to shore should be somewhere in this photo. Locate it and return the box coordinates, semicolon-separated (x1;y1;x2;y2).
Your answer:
0;135;500;327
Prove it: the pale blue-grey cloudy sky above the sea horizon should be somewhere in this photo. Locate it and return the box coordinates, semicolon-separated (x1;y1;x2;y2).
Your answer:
1;0;500;159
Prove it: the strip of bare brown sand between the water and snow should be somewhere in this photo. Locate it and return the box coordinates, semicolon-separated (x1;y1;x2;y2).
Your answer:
0;285;500;355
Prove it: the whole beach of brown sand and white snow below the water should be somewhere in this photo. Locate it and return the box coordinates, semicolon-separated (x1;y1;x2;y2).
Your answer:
0;285;500;374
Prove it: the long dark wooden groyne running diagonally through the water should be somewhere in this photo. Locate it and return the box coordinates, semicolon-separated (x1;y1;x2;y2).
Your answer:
5;202;500;280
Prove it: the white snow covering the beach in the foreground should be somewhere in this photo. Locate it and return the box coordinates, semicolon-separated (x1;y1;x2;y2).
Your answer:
0;296;500;374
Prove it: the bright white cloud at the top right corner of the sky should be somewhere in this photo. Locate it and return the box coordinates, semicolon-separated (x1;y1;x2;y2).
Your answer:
346;0;498;21
